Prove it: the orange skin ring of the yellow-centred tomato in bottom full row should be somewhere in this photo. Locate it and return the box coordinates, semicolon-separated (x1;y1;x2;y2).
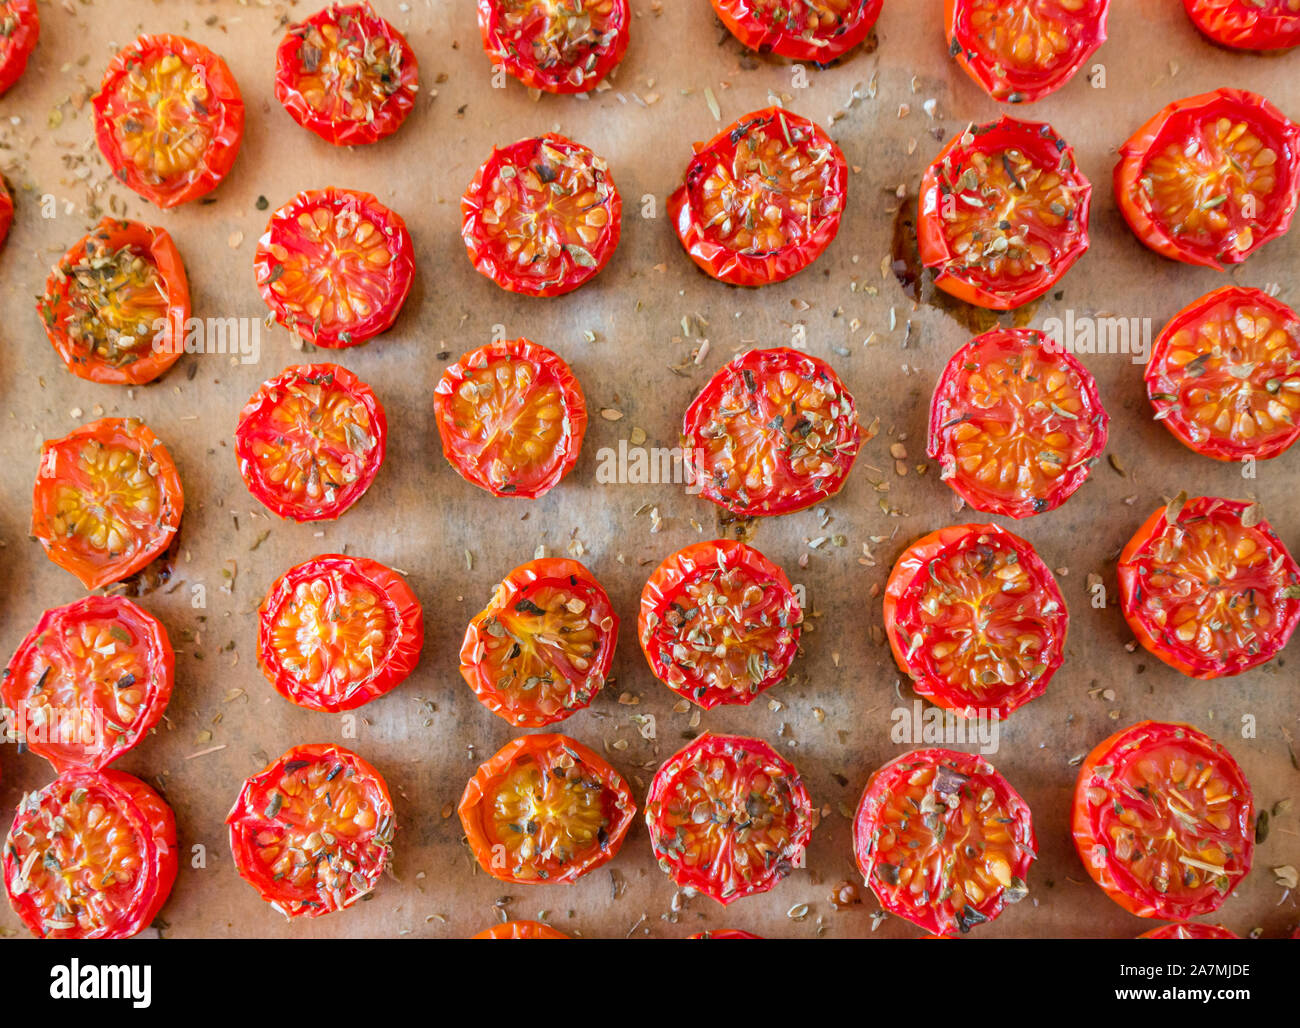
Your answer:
458;734;637;885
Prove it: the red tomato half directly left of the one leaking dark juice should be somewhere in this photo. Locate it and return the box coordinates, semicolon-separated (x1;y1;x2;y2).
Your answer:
668;107;849;286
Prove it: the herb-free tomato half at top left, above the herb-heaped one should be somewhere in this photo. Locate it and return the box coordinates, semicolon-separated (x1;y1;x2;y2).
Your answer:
91;35;244;208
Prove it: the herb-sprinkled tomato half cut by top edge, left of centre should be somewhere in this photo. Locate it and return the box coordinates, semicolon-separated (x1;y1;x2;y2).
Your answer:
478;0;632;92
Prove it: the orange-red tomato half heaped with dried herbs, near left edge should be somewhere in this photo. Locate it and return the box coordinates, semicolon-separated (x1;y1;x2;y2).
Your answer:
36;218;190;386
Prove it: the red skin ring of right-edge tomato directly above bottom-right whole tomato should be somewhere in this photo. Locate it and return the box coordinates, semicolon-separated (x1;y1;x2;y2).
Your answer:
1118;496;1300;678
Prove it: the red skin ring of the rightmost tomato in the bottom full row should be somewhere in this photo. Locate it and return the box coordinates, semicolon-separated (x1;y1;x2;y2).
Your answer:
1071;721;1255;921
